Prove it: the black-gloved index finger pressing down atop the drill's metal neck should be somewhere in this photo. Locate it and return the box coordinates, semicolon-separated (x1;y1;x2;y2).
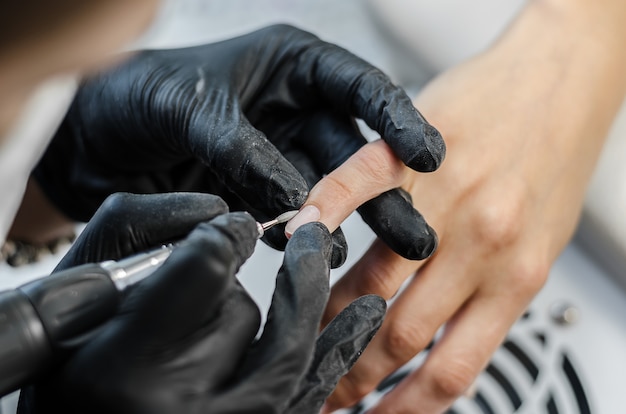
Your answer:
111;213;258;343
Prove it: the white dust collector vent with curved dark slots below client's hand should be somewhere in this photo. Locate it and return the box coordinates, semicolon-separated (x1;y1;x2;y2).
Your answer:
348;312;595;414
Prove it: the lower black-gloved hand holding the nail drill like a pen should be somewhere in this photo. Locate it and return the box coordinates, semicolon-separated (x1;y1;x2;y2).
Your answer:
19;193;385;414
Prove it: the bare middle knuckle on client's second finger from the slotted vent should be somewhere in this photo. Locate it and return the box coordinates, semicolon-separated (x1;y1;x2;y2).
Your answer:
385;319;433;364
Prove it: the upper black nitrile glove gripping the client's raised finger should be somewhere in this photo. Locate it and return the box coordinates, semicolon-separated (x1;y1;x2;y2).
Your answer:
35;26;445;259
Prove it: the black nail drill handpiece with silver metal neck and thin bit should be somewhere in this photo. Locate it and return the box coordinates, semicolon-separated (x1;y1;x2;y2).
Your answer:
0;211;298;396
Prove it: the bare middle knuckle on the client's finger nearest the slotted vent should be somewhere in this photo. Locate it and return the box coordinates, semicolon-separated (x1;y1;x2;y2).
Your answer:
430;359;477;399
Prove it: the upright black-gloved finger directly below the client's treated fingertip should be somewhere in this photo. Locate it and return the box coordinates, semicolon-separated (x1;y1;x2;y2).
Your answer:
212;223;331;413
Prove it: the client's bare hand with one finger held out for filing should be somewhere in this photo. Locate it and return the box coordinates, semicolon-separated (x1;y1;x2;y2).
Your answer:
288;2;626;414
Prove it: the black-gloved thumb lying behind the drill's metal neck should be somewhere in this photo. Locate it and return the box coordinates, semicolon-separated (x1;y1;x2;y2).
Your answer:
56;193;228;270
